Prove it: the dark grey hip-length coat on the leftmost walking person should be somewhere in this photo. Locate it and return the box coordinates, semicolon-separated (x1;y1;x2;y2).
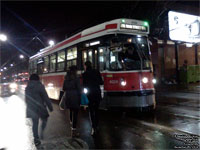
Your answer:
25;80;53;118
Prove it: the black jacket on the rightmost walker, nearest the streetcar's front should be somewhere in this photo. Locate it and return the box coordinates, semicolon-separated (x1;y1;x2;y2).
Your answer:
82;69;103;102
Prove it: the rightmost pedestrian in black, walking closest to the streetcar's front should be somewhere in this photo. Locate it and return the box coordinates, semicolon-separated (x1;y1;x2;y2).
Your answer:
82;61;103;135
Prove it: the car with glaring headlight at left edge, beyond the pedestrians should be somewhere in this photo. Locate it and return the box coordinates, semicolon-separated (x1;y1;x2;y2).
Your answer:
0;78;18;96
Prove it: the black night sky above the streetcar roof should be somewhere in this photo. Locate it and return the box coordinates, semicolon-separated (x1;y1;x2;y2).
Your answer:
0;1;199;68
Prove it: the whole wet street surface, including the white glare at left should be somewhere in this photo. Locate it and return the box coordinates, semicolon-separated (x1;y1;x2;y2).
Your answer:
0;89;200;150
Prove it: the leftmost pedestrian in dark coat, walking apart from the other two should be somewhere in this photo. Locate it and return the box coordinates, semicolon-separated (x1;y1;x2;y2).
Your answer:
25;74;53;146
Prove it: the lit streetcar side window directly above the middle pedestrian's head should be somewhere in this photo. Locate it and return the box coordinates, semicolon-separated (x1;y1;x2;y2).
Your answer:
67;47;77;70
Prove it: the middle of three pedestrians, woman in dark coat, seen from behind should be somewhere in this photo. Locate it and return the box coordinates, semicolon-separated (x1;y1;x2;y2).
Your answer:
63;66;81;136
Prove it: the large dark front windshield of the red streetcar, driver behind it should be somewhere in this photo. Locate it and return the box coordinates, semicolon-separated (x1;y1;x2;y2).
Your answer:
110;37;151;71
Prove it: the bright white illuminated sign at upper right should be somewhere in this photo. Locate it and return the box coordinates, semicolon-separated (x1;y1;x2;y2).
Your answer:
168;11;200;43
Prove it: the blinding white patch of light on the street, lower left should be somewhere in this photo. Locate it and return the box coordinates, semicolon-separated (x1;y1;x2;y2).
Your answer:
0;95;36;150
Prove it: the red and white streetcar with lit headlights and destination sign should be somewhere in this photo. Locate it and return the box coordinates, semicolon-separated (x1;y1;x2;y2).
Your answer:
29;19;156;109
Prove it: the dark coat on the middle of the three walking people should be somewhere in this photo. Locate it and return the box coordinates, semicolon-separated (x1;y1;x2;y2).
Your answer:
63;77;81;109
